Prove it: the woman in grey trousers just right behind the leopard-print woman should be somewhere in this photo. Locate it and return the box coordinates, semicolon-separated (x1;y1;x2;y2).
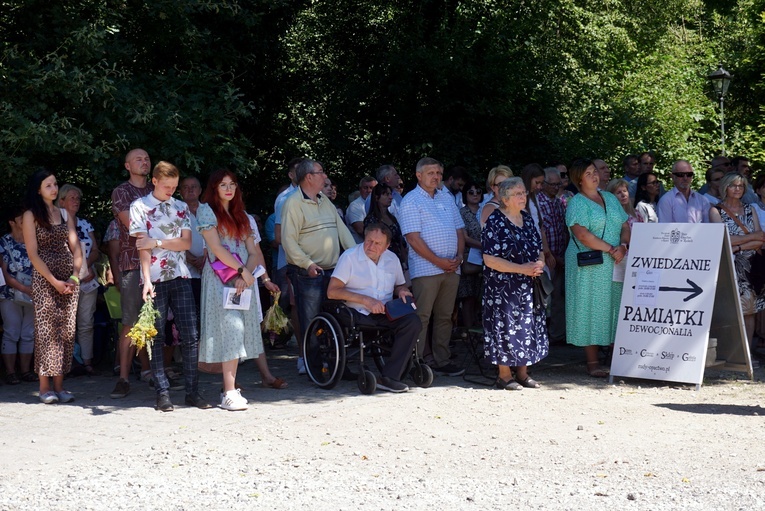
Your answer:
56;184;99;376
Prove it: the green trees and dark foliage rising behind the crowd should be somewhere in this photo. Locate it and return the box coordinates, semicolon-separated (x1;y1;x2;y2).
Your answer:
0;0;765;224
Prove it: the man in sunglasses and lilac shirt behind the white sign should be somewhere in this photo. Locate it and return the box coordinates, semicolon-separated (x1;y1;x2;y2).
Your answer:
656;160;709;223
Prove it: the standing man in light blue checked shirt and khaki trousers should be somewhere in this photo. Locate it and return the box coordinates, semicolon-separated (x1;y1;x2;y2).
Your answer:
399;158;465;376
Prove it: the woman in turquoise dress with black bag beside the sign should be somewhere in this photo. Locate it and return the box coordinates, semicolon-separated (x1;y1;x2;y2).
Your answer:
566;159;630;378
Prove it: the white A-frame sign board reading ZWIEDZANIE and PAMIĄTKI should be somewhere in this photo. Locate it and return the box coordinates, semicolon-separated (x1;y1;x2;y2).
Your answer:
611;223;743;385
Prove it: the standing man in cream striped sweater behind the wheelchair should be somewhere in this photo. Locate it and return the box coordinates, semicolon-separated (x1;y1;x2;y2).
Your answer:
281;158;356;374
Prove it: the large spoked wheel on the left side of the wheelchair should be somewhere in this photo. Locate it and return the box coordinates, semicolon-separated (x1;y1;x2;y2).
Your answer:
303;312;345;389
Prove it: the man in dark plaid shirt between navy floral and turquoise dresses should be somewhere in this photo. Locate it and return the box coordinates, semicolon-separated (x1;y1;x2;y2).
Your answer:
537;167;568;342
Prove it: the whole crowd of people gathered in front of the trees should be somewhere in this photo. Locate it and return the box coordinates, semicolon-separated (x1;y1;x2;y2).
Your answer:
0;149;765;412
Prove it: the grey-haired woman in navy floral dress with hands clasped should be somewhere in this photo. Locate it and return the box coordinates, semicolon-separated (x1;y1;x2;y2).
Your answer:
481;177;549;390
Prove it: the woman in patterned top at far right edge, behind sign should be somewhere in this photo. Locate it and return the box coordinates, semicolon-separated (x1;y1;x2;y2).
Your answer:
709;173;765;348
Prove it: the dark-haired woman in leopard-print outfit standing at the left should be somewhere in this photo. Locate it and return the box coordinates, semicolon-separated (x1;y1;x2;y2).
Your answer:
21;170;82;404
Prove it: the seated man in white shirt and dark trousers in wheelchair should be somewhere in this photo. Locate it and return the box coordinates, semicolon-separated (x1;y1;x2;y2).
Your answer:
327;223;422;392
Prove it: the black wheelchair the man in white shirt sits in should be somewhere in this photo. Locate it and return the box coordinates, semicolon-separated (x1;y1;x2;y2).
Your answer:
303;300;433;395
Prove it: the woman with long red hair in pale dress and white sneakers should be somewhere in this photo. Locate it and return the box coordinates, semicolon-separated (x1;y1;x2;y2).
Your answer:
197;169;280;410
